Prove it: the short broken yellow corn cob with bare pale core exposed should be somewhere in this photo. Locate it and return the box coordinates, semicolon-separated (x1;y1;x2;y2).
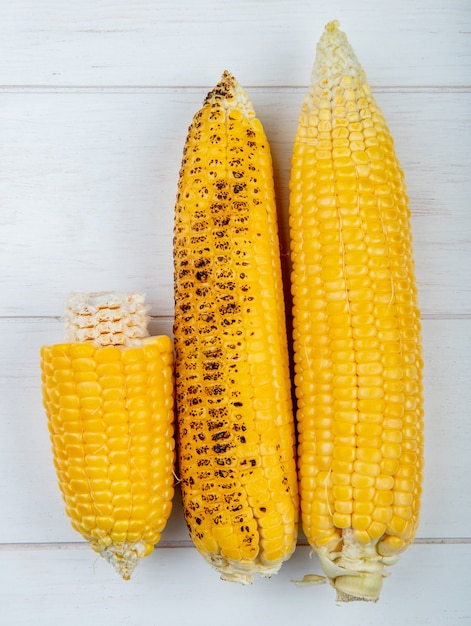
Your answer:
41;293;175;579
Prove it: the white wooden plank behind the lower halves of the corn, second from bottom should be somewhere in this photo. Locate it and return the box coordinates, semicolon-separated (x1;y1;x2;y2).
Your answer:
0;318;471;543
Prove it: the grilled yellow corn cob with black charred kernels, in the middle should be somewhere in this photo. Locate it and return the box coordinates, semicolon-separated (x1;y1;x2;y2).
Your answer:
174;72;298;583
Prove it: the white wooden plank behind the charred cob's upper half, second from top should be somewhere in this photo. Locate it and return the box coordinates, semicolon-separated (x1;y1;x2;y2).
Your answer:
0;89;471;316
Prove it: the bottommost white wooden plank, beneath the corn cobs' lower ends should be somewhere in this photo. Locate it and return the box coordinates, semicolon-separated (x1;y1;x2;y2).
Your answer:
0;544;471;626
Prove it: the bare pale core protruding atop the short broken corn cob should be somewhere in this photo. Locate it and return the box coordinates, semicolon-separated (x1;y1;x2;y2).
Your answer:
65;292;150;347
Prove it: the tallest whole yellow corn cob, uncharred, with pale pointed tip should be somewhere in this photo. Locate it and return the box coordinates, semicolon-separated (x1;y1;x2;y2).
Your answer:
290;21;423;600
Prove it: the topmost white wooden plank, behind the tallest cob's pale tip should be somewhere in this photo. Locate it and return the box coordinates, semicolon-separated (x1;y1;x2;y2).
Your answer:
0;0;471;86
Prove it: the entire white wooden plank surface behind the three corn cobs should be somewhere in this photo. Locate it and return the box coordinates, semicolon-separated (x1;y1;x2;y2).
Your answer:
0;0;471;626
